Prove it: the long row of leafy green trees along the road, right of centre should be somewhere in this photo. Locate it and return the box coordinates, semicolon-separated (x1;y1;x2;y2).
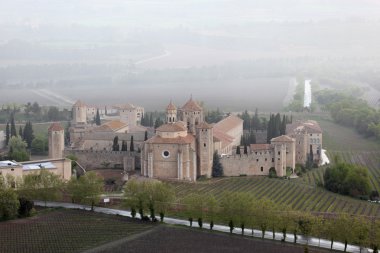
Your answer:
124;180;380;252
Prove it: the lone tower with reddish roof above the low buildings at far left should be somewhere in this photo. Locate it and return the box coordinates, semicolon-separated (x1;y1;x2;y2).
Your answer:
48;123;65;159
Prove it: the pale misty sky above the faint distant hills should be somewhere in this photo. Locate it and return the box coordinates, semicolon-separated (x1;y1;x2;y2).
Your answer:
0;0;380;28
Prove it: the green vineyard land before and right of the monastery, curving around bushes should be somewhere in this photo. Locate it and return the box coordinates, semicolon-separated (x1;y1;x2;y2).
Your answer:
171;114;380;216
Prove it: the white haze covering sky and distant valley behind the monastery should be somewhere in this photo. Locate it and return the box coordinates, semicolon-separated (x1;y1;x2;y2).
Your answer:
0;0;380;111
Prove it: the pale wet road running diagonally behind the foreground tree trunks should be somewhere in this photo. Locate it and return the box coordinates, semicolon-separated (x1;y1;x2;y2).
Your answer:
34;201;372;253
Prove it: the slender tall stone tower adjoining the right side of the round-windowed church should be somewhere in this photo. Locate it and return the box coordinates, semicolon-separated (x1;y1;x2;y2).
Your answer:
196;122;214;177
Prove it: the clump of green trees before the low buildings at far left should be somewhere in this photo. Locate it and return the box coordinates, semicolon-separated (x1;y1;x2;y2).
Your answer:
0;169;104;220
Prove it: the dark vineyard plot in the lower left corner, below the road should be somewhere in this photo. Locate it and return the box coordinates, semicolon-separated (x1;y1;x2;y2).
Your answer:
0;210;154;253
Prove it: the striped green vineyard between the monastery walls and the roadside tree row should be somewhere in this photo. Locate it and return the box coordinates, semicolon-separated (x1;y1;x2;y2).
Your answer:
171;177;380;216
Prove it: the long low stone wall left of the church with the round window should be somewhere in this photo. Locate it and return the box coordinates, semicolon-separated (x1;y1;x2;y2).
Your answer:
65;150;140;171
